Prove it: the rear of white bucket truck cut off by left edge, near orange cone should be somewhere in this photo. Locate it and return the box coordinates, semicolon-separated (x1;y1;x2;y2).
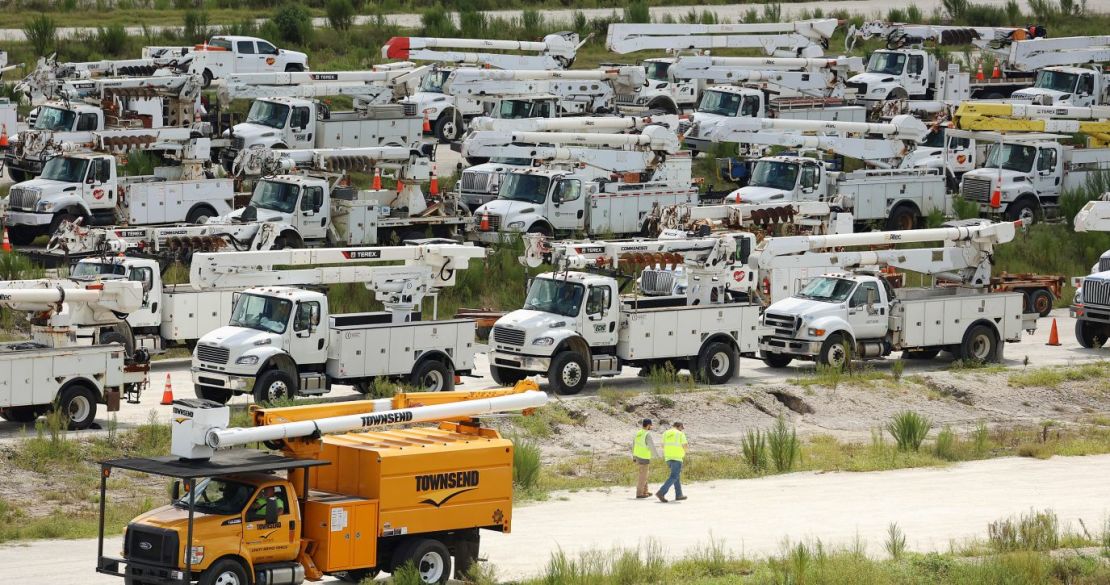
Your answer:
0;280;148;430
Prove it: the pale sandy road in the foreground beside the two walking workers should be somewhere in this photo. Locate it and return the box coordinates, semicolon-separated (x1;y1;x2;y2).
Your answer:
0;455;1110;585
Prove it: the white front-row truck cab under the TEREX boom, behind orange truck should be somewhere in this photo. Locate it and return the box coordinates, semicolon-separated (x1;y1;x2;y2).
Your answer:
193;286;329;403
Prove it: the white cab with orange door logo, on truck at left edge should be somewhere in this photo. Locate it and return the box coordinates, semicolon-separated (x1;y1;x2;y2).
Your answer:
4;152;119;245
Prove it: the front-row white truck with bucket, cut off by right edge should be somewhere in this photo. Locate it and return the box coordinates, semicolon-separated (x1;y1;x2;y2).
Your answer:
1069;202;1110;349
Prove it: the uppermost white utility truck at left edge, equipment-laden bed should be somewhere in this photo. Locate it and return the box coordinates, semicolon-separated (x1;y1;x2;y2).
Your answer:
3;75;205;182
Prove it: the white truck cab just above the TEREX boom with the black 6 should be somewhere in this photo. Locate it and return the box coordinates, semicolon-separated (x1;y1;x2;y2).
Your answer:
216;174;332;249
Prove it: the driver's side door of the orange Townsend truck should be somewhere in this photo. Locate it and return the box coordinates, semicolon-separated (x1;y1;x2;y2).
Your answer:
243;485;301;565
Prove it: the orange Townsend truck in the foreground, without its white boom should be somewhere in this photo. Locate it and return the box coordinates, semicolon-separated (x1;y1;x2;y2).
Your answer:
97;393;513;585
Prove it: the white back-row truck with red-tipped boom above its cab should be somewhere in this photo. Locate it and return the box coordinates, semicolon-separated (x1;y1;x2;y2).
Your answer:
382;32;585;142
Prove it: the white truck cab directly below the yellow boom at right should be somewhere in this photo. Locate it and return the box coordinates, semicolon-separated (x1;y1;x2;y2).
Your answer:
960;140;1066;222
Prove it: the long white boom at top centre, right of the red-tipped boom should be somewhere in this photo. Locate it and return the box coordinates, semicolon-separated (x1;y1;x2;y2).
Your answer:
605;19;838;57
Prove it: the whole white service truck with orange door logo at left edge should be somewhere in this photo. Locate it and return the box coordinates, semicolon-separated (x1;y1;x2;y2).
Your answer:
3;152;235;245
